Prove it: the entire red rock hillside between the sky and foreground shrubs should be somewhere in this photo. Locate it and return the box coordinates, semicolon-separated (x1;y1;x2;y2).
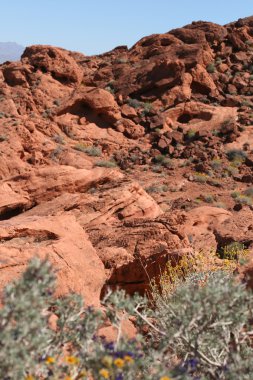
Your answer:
0;17;253;305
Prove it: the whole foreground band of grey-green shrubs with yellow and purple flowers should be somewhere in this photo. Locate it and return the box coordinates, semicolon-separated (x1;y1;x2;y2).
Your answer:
0;254;253;380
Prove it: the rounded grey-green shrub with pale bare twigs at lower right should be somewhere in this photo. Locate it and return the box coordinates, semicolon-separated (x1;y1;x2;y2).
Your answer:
153;271;253;380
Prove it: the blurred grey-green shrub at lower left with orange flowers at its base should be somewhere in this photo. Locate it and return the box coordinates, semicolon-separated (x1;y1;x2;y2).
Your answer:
0;259;169;380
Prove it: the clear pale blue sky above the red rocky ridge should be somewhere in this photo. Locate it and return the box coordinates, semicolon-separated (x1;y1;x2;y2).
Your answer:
0;0;253;55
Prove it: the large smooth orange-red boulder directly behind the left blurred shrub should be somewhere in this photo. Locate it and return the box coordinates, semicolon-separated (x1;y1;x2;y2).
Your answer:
0;214;105;306
